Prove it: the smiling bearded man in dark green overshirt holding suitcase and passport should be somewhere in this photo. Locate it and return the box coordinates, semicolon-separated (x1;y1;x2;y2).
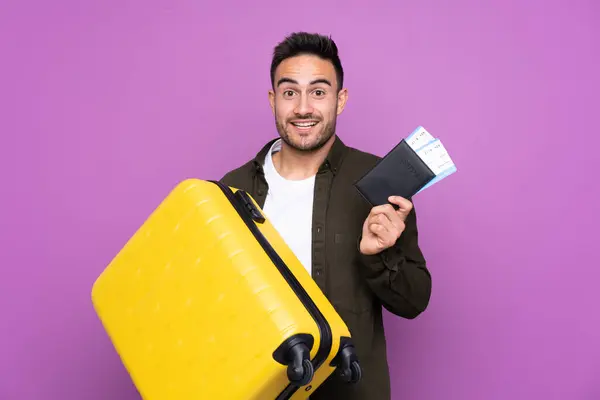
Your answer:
221;32;431;400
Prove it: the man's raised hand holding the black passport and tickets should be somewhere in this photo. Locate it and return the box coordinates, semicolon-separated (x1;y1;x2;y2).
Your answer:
360;196;413;255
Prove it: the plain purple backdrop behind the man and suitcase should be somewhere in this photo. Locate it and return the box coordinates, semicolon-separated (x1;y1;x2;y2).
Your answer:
0;0;600;400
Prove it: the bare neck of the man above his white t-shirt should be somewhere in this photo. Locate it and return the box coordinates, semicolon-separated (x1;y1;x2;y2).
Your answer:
273;135;335;180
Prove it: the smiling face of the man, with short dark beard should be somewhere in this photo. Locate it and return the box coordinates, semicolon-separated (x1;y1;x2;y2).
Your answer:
269;55;347;151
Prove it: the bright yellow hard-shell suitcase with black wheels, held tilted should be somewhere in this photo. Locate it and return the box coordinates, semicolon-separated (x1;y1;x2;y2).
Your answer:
92;179;361;400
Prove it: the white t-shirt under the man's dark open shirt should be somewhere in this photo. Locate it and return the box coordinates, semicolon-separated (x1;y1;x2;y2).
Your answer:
263;139;315;274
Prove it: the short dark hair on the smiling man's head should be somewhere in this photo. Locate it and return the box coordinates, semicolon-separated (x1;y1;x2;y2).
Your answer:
271;32;344;90
